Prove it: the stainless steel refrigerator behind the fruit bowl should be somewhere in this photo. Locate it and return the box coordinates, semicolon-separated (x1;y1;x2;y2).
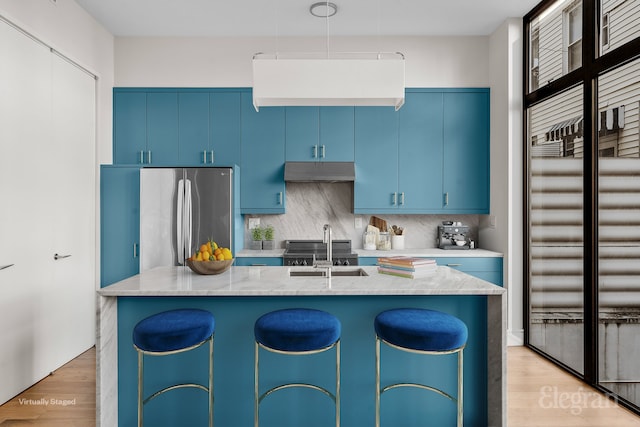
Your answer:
140;168;235;272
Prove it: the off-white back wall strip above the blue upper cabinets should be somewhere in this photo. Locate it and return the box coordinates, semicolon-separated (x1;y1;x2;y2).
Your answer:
115;37;490;87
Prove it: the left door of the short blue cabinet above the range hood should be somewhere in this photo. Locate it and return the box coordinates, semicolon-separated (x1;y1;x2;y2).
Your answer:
285;107;320;162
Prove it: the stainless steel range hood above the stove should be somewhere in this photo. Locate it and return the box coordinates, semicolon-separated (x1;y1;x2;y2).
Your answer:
284;162;356;182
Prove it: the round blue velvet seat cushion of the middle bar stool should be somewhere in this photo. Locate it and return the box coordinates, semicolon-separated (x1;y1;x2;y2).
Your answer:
254;308;341;352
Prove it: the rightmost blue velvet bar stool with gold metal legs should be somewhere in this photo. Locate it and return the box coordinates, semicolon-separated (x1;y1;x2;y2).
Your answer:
374;308;469;427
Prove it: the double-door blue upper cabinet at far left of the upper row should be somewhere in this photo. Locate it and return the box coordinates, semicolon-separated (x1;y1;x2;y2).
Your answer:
113;91;178;166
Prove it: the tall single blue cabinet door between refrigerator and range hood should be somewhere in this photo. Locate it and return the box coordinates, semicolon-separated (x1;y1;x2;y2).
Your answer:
240;92;285;214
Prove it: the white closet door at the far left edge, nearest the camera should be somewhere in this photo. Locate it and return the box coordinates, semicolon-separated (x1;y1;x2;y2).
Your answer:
0;22;52;403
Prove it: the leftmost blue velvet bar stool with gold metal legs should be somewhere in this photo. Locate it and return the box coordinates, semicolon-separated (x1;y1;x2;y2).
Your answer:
133;309;215;427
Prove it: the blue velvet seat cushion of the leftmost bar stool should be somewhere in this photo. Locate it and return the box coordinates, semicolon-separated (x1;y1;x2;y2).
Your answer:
133;309;216;352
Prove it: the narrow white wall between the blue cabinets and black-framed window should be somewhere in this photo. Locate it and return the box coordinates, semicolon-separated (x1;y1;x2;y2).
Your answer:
479;19;524;344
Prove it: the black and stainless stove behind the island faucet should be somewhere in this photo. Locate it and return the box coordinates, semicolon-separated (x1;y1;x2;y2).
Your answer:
282;240;358;266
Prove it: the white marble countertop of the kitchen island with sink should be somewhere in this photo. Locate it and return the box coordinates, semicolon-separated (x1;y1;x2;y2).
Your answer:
98;266;505;297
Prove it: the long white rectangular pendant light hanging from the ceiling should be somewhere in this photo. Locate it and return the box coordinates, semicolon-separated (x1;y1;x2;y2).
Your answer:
253;52;405;111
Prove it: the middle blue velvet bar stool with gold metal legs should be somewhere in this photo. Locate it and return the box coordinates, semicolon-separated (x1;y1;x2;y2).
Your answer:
254;308;342;427
